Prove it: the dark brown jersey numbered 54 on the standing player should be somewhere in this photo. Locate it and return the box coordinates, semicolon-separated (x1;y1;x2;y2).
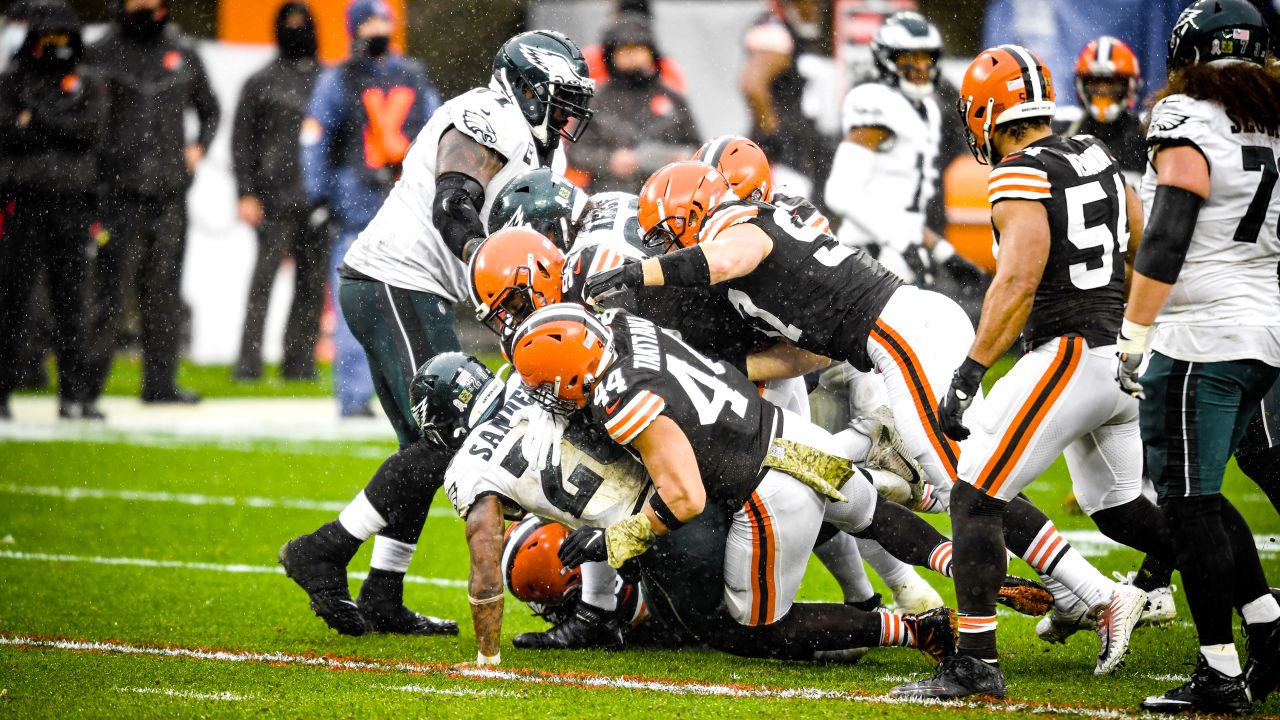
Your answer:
987;135;1129;350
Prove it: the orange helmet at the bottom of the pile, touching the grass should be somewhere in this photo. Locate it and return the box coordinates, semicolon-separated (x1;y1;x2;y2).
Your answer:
502;515;582;606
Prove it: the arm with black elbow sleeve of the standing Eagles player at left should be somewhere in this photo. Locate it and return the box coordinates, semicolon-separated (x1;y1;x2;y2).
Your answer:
431;127;507;261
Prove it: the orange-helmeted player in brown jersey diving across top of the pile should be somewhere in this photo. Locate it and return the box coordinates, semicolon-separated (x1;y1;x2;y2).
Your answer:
584;161;1115;655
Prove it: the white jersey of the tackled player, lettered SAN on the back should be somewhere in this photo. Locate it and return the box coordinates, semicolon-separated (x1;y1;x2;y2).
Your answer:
444;374;653;529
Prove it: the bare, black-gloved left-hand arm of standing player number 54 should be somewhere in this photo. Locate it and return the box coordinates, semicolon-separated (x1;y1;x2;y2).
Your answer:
938;200;1050;441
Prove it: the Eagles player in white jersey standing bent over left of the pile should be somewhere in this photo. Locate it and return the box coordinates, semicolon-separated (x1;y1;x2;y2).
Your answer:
279;31;594;635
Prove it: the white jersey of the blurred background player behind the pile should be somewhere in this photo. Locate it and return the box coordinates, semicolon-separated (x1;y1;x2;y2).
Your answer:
828;82;942;249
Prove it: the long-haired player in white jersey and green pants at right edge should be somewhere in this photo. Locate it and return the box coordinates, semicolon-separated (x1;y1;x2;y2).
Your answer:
1117;0;1280;712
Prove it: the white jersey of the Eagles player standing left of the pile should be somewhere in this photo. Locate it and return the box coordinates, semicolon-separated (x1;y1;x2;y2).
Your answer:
344;81;566;302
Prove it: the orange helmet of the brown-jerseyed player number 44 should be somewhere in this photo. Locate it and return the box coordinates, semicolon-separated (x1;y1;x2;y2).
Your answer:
511;302;611;414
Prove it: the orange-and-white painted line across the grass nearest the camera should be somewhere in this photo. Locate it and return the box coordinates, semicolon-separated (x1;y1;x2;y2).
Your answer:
0;634;1139;719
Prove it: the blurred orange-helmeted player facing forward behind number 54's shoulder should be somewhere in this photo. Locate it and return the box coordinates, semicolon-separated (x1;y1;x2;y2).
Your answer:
1053;35;1147;188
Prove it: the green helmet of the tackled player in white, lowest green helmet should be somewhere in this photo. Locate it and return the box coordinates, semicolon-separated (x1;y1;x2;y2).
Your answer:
408;352;506;451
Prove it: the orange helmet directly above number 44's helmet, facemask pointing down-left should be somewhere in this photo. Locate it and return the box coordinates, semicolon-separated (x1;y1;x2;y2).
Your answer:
467;227;564;337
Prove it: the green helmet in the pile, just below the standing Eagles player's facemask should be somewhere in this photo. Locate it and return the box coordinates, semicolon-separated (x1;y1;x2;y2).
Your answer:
489;168;588;252
